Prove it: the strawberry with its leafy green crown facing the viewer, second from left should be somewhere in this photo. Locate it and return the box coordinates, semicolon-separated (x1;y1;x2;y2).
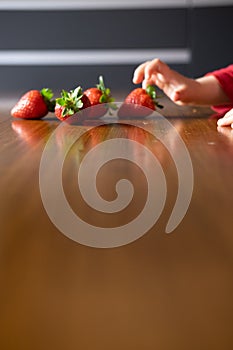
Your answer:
55;86;91;121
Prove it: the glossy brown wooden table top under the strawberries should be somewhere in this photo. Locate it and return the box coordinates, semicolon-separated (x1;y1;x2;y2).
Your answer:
0;100;233;350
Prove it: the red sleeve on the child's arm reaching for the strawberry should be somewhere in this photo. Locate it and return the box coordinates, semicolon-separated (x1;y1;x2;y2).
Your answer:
207;64;233;114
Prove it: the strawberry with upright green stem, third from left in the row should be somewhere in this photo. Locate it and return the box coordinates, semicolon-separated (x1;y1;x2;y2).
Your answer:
84;76;114;118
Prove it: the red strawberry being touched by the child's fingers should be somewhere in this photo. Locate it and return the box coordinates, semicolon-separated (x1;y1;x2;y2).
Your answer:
118;85;163;117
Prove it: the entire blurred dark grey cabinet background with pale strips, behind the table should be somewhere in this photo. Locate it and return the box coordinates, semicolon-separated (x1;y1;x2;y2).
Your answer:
0;0;233;95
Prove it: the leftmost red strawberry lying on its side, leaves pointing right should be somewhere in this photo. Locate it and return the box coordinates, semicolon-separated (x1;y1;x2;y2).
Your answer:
11;88;55;119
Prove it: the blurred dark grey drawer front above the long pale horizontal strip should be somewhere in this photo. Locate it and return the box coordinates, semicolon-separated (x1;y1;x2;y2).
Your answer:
0;9;188;50
